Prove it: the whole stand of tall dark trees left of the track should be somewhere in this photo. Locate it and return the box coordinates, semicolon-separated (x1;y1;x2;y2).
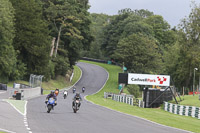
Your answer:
0;0;93;83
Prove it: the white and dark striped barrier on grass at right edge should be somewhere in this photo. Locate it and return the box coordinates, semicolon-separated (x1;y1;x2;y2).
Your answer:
164;102;200;119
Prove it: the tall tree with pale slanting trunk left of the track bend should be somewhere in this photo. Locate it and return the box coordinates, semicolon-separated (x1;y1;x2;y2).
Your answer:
43;0;92;67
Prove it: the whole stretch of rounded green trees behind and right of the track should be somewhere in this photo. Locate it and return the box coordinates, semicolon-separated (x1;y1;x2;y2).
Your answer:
86;3;200;89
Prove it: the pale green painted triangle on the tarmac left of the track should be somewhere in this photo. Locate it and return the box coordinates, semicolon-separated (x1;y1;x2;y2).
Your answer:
5;99;26;114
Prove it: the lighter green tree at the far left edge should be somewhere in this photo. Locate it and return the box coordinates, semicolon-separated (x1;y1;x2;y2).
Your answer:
0;0;17;83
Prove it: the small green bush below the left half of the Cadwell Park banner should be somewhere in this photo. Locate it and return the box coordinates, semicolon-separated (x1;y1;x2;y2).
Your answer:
127;85;142;98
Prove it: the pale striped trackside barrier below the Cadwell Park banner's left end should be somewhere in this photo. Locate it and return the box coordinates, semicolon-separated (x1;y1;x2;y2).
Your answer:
104;92;144;108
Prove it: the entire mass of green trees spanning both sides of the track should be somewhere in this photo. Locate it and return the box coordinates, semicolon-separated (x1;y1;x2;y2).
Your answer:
0;0;200;92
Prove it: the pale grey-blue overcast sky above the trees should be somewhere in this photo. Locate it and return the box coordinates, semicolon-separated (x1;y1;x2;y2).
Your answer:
89;0;200;27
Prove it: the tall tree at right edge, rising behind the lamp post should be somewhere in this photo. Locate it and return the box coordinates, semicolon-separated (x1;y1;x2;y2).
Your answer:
166;3;200;88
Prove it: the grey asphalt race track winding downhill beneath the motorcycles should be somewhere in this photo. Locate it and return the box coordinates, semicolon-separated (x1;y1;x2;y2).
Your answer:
27;63;189;133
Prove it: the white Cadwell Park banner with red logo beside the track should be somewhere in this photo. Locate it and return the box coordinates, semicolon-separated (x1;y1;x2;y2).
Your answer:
128;73;170;86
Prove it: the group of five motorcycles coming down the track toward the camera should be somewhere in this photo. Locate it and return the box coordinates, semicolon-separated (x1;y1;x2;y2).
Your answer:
46;87;85;113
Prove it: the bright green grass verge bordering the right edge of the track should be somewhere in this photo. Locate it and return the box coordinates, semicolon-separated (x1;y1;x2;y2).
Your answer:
81;61;200;132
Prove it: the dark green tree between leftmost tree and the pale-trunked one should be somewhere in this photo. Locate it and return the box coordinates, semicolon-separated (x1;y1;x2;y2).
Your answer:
10;0;50;79
